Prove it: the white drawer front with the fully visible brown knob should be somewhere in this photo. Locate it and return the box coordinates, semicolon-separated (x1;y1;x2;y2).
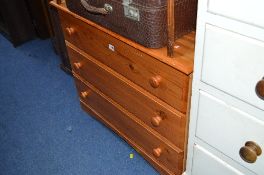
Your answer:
196;91;264;175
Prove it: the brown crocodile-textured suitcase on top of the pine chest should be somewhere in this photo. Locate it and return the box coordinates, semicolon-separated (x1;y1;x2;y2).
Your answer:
66;0;197;48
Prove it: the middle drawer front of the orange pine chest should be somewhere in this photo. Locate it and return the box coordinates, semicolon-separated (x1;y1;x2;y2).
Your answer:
68;44;186;149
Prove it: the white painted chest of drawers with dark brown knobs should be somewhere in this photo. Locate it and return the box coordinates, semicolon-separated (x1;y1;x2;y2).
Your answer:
185;0;264;175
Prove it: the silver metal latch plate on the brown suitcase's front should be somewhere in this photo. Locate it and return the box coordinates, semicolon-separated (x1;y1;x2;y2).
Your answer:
122;0;140;21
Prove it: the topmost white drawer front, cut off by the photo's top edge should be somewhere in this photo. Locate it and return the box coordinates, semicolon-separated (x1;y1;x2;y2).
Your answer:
208;0;264;27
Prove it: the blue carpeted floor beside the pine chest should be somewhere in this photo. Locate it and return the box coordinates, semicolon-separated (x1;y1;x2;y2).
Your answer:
0;35;158;175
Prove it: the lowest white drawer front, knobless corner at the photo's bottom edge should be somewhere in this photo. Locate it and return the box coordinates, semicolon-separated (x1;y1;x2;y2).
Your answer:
192;145;243;175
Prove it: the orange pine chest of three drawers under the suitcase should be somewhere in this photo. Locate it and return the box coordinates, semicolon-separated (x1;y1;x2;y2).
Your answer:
51;2;194;175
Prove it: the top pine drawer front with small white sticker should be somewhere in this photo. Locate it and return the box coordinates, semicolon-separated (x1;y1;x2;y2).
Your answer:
61;9;189;113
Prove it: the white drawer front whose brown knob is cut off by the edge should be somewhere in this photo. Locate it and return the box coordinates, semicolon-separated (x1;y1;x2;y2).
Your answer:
202;25;264;110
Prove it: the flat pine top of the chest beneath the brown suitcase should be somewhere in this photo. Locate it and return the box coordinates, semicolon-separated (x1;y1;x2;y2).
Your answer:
50;1;195;75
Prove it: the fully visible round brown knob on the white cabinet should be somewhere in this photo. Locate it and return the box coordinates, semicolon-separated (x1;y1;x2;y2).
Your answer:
239;141;262;163
